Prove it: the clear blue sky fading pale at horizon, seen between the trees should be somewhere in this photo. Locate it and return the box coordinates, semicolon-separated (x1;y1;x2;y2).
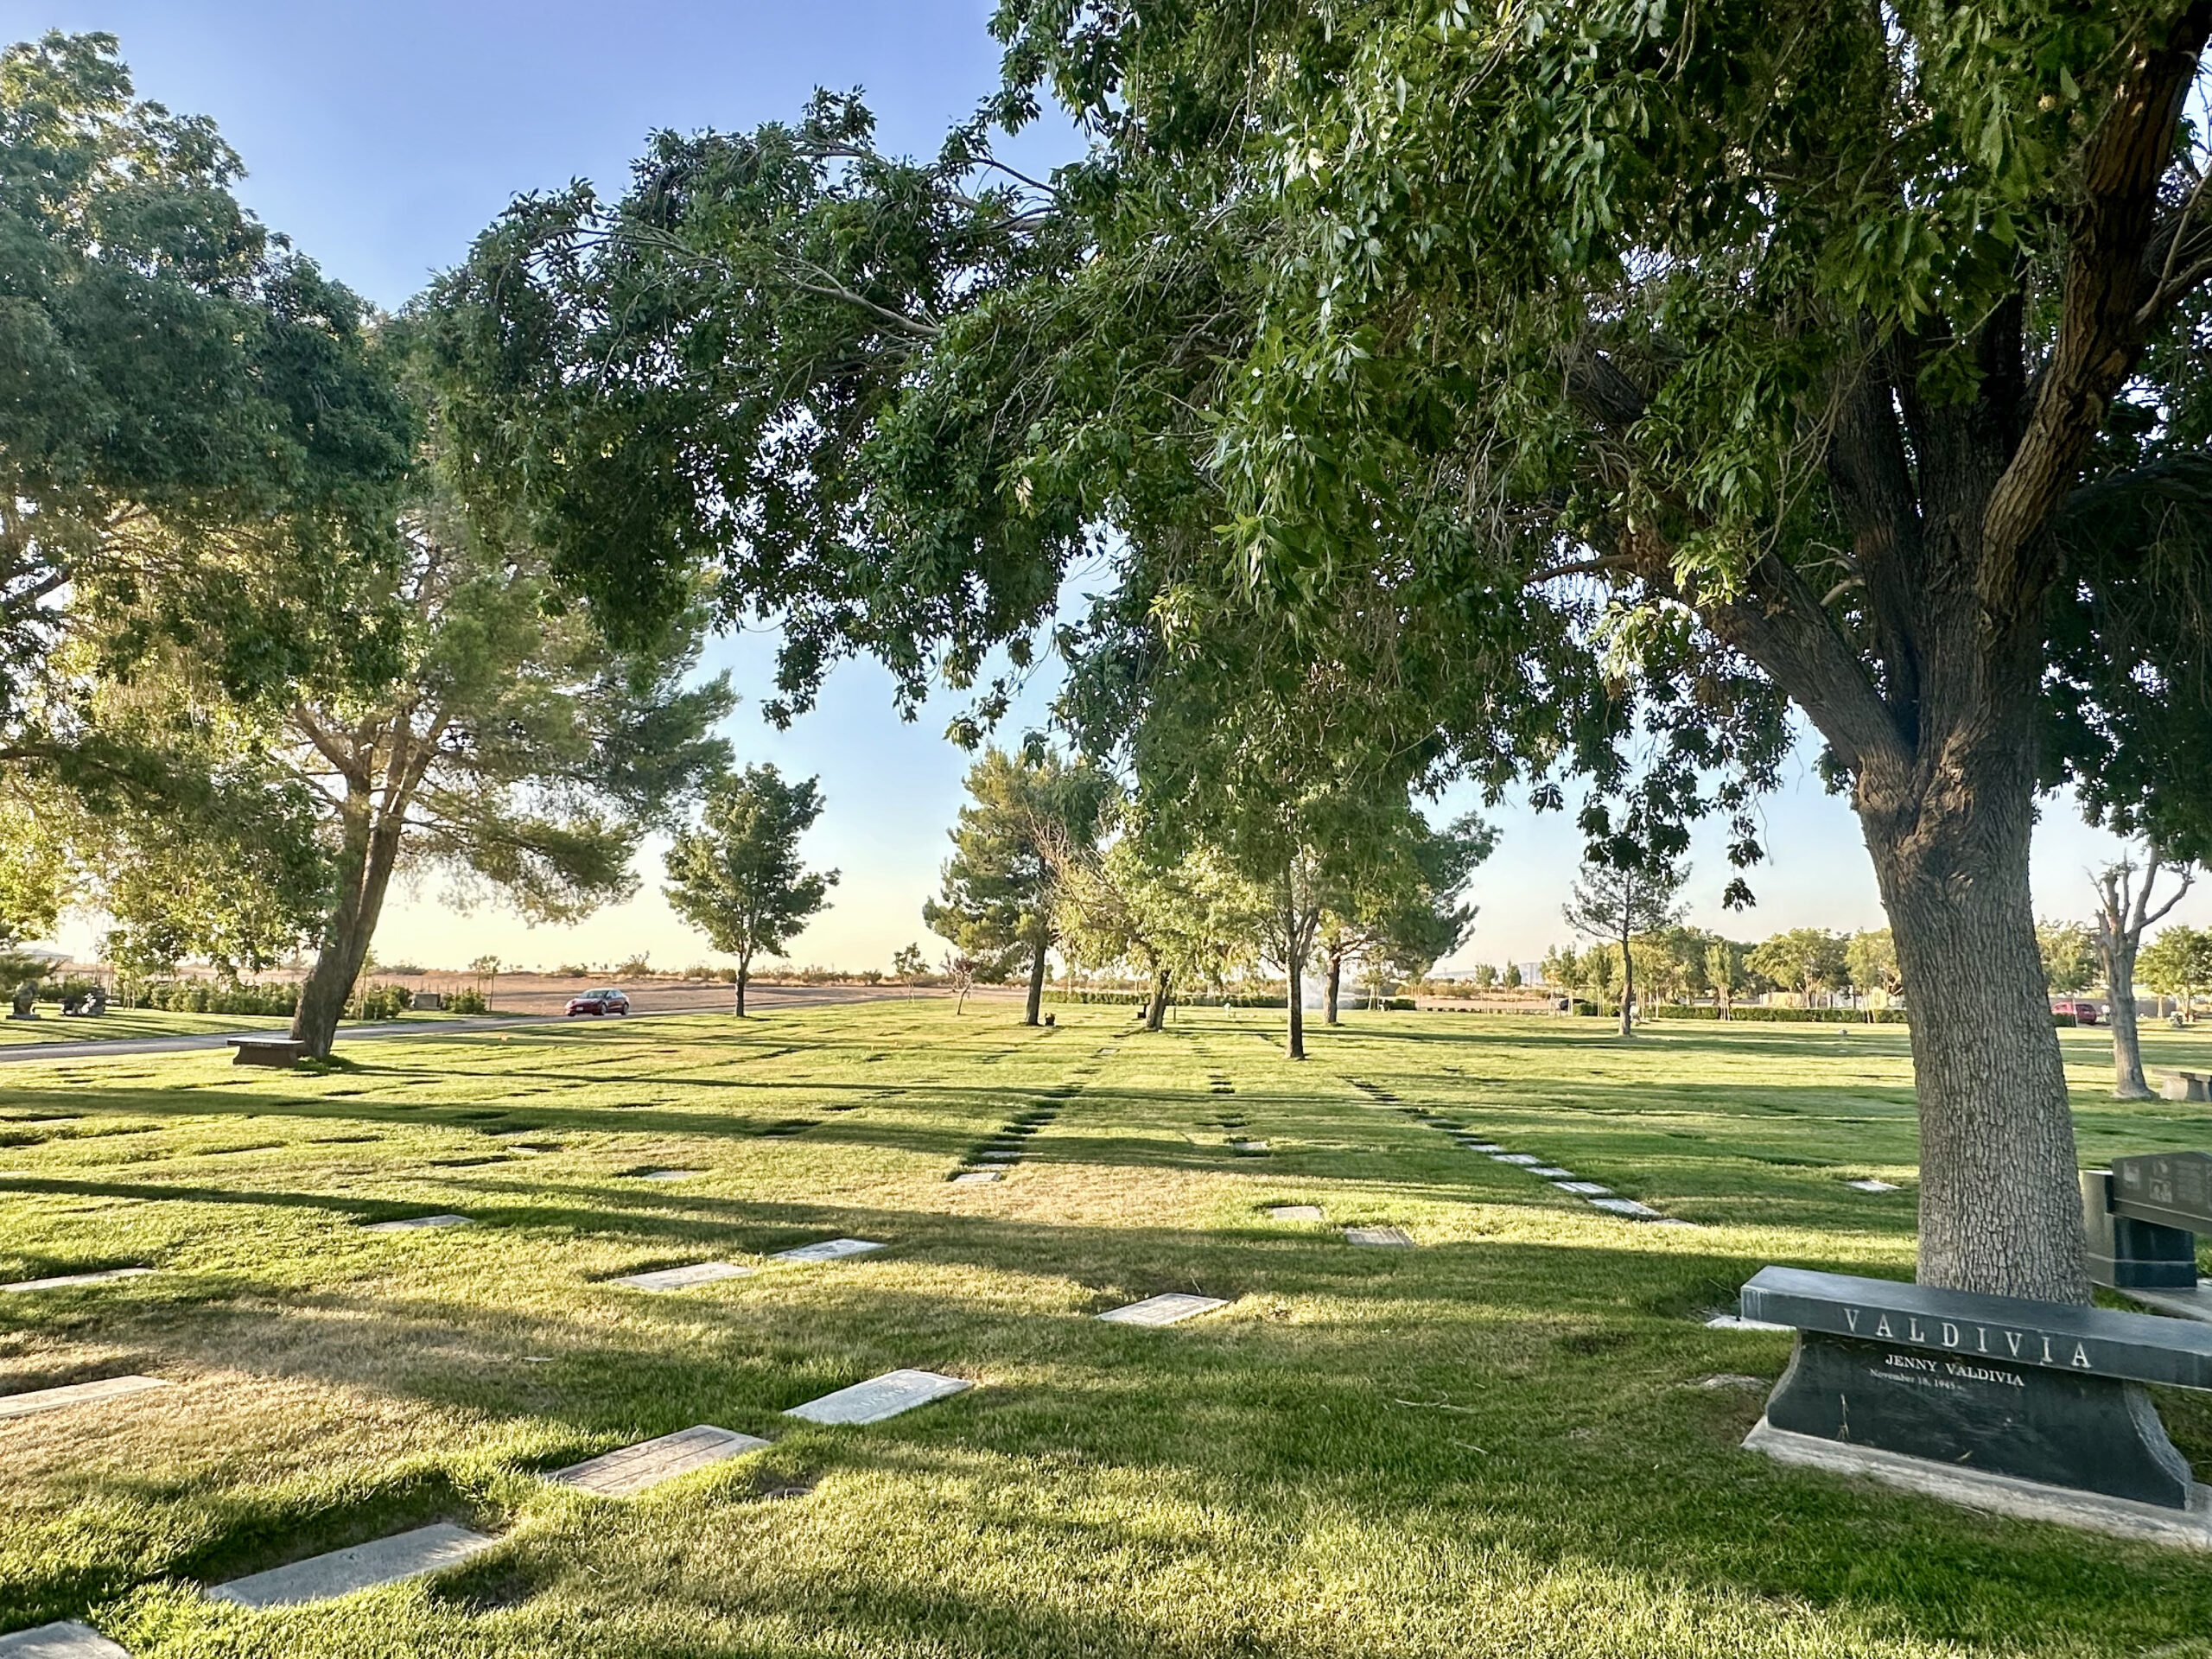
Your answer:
21;0;2212;967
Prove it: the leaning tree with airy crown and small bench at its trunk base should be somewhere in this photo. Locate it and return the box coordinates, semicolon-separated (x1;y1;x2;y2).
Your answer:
272;482;730;1055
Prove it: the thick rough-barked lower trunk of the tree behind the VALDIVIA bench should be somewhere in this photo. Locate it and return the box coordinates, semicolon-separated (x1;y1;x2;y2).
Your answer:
1853;760;2088;1303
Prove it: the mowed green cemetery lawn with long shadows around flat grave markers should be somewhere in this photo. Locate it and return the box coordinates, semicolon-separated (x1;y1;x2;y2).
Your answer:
0;1000;2212;1659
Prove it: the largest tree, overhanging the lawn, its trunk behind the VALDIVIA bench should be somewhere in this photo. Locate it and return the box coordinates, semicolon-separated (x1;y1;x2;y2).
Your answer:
449;0;2212;1299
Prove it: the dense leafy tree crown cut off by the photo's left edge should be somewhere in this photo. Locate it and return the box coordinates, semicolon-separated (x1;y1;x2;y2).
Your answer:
0;33;414;772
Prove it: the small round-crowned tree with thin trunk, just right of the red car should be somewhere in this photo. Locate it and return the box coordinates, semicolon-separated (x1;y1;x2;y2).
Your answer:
664;766;838;1020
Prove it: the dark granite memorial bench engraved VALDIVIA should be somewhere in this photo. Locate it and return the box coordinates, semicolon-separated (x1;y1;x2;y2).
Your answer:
1741;1268;2212;1541
